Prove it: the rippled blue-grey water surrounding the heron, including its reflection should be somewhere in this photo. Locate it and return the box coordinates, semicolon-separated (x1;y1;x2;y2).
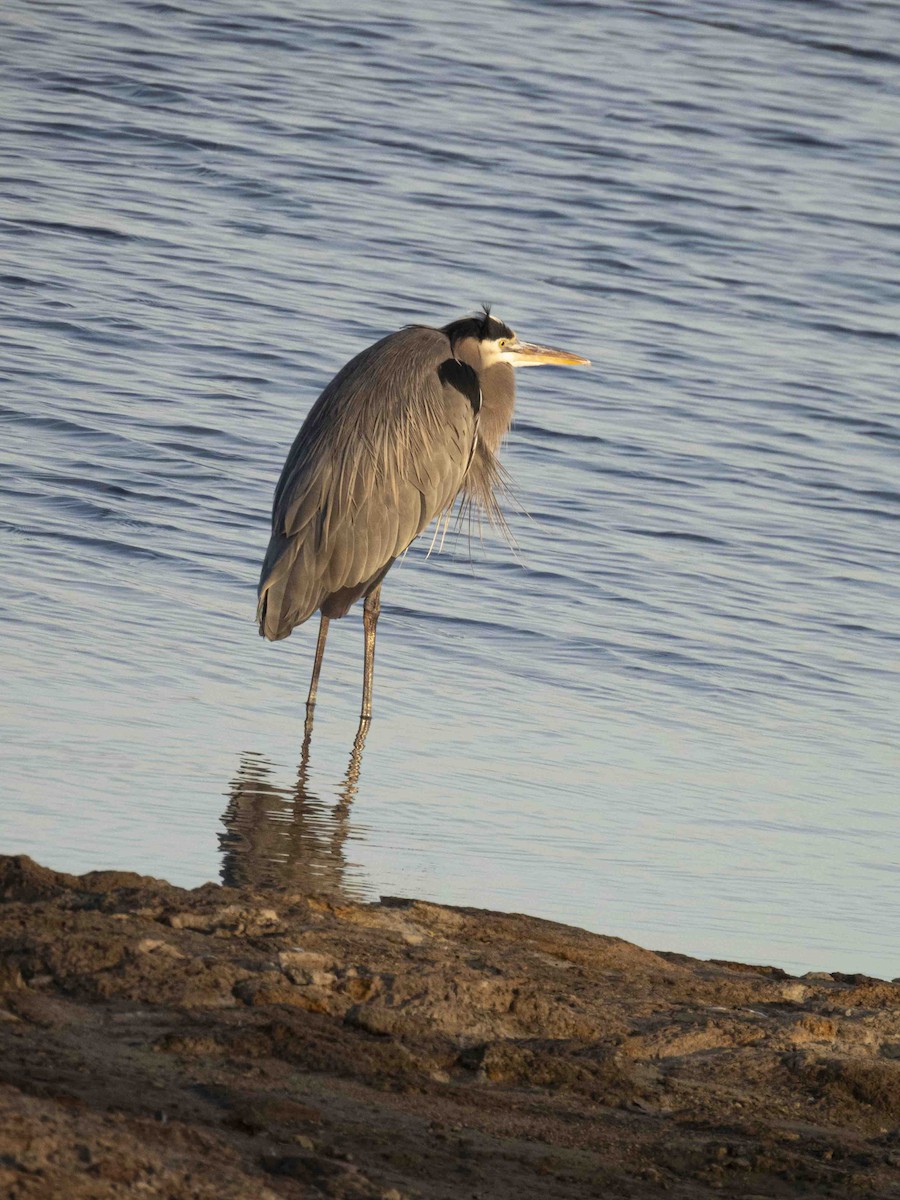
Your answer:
0;0;900;977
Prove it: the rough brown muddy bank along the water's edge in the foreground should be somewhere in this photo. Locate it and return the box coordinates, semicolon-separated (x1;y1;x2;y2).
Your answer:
0;857;900;1200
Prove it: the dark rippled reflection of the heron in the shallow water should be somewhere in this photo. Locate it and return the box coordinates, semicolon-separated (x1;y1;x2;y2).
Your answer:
218;722;367;899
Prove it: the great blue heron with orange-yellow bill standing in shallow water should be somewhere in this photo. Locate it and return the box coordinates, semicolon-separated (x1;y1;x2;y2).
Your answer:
257;308;588;722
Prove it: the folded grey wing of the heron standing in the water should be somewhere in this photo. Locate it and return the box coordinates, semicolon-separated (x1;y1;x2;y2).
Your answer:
259;326;480;637
